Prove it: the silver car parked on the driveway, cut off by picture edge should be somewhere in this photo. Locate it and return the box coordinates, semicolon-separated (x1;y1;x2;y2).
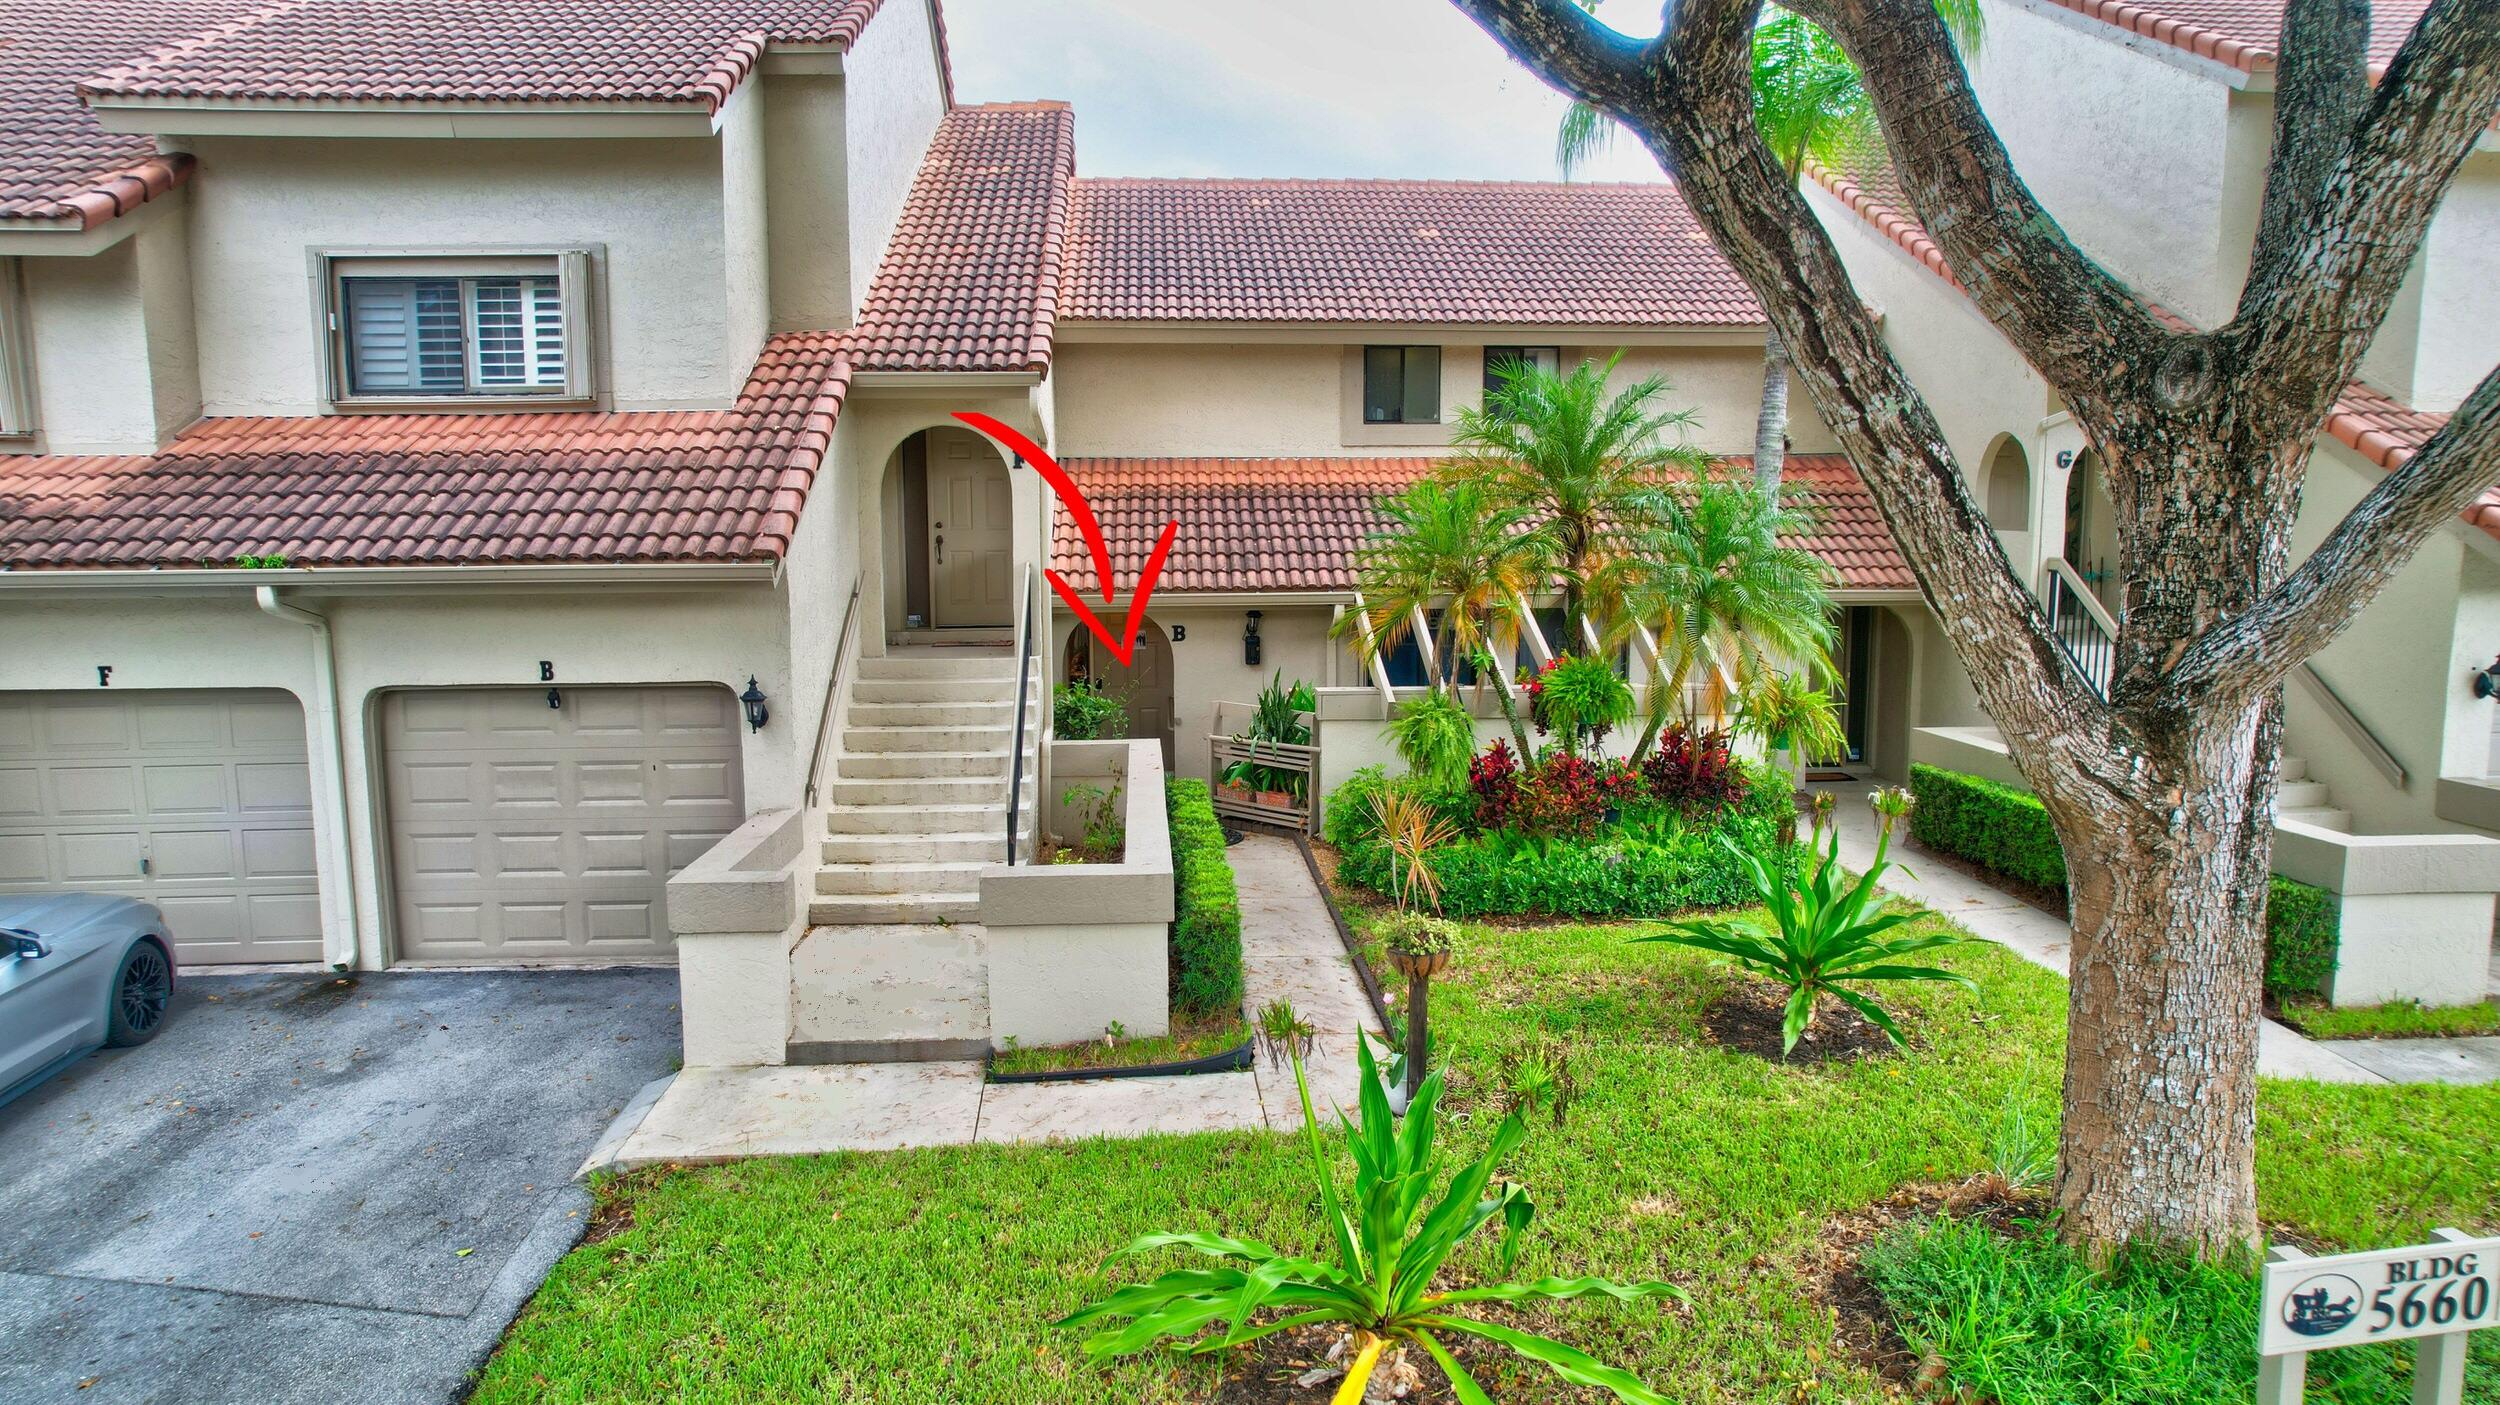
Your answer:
0;893;173;1103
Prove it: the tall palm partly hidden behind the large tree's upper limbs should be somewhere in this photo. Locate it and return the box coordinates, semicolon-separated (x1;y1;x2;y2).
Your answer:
1555;0;1983;498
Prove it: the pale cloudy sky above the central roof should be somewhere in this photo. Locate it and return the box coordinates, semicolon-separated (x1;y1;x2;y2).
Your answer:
943;0;1663;180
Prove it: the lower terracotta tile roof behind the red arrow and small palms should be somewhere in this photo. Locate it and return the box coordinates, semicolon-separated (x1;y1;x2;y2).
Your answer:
1050;455;1915;595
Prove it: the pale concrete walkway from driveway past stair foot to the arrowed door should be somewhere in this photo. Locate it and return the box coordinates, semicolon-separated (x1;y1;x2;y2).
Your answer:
602;835;1378;1170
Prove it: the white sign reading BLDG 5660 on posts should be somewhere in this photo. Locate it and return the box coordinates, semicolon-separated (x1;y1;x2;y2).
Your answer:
2258;1230;2500;1405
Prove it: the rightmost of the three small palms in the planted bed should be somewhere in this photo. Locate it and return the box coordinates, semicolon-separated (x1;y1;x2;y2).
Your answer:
1603;473;1838;763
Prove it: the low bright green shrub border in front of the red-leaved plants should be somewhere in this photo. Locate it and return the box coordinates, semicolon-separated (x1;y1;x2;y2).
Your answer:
1328;770;1795;918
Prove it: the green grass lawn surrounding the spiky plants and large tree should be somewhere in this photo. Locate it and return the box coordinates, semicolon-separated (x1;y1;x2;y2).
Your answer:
475;900;2500;1405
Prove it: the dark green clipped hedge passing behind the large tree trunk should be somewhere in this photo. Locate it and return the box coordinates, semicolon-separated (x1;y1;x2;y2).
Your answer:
1910;765;2338;998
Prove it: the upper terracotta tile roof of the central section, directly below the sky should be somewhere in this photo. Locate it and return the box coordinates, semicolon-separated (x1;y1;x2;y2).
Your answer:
1060;180;1763;328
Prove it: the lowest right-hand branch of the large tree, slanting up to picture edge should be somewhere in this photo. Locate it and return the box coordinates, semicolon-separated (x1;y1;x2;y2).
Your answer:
2170;360;2500;695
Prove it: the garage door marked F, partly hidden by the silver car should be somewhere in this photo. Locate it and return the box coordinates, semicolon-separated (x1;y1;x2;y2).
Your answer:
0;688;323;965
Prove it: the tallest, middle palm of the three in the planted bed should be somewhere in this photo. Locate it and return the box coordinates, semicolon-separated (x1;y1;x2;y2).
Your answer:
1443;353;1710;638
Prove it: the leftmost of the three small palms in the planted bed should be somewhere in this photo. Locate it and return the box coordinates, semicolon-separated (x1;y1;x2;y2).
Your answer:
1335;478;1553;710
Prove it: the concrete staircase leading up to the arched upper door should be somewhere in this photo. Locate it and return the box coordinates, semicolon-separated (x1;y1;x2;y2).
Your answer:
808;645;1040;925
